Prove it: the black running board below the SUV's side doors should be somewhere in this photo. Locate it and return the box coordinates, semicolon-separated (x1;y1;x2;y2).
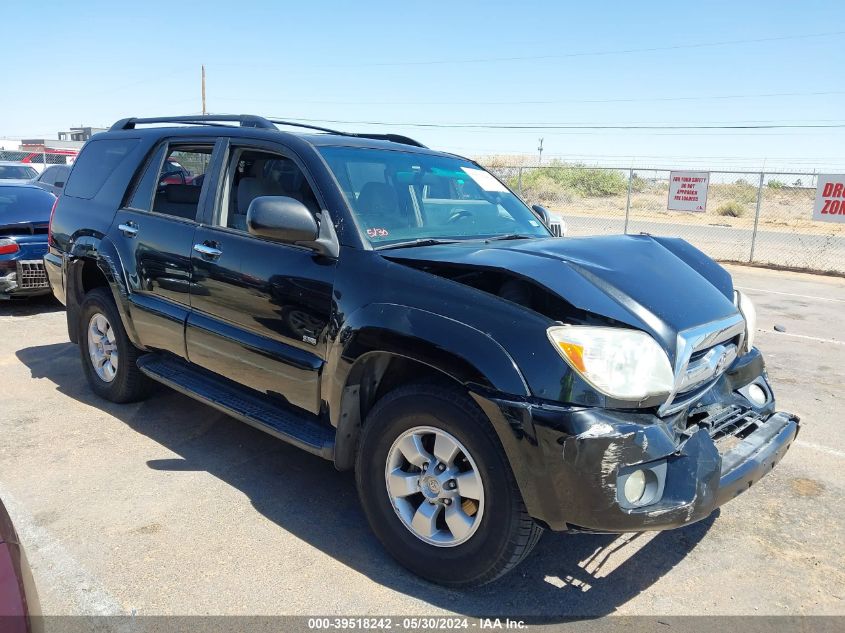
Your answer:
138;354;335;460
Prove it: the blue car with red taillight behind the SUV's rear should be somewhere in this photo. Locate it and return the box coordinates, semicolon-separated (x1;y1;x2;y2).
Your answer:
0;184;56;300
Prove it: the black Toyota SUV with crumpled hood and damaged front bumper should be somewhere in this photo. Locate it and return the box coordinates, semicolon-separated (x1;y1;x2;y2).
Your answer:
45;115;798;586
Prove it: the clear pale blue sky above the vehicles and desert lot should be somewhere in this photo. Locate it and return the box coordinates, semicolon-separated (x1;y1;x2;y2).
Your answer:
0;0;845;170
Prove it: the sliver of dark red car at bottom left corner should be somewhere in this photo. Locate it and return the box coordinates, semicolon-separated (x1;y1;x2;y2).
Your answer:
0;502;40;633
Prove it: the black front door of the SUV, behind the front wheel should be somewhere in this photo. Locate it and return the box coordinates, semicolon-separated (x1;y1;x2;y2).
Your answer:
186;143;335;413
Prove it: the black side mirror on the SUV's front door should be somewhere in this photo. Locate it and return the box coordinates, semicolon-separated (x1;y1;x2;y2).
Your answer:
246;196;319;243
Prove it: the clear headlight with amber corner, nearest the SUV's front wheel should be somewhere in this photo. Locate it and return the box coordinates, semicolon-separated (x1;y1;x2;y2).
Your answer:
548;325;675;400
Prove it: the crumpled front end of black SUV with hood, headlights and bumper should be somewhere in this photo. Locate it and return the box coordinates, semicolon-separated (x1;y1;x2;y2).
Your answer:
390;235;799;532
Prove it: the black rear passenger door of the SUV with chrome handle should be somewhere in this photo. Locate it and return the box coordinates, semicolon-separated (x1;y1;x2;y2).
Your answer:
109;138;221;358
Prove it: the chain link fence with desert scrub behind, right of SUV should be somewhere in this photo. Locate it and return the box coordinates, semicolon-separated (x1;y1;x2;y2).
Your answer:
488;163;845;273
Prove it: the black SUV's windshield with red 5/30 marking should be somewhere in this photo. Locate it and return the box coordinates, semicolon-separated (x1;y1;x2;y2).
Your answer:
320;147;550;247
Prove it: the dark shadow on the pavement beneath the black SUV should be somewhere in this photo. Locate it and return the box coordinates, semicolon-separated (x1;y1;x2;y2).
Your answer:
17;343;715;622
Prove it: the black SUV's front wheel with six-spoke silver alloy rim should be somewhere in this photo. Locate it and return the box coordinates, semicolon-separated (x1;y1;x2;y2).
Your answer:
356;384;542;587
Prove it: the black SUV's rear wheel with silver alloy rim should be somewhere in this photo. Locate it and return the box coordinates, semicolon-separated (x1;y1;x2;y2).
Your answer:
78;288;150;403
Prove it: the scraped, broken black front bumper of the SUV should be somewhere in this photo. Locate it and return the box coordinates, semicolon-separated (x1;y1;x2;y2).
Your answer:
479;350;799;533
